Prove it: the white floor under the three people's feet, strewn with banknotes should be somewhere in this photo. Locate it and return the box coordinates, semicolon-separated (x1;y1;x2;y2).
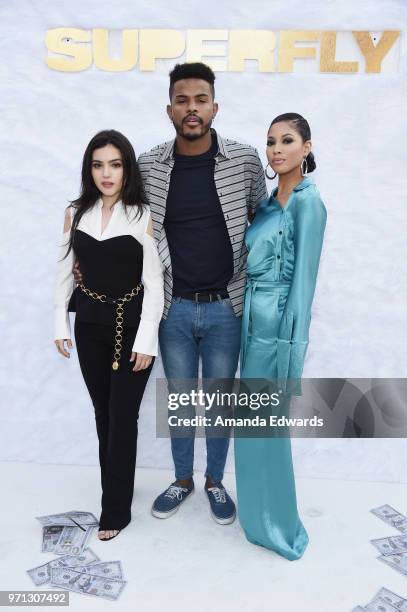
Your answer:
0;463;407;612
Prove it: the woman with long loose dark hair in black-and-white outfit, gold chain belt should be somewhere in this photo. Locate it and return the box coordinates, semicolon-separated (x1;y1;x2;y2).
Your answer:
54;130;164;541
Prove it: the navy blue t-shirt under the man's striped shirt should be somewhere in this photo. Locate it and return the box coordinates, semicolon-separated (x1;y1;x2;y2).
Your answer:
164;134;233;295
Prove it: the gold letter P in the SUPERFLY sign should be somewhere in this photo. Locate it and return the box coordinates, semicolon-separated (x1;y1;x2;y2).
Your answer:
140;30;185;71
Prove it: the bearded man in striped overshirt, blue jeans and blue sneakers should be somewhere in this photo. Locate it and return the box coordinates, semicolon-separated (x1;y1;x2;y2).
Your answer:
142;63;267;524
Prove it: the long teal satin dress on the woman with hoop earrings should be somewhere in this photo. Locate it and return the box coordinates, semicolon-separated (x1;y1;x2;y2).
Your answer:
235;177;326;560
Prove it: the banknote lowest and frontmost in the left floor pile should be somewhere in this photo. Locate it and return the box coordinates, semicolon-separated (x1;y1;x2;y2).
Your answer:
50;567;126;600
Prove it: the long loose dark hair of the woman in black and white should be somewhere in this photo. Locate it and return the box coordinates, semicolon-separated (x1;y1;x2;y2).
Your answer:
65;130;145;257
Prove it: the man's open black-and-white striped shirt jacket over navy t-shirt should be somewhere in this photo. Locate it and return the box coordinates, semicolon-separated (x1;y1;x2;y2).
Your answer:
138;134;267;318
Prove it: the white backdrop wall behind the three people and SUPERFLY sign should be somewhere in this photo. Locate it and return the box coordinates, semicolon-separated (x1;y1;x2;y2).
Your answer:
0;0;407;482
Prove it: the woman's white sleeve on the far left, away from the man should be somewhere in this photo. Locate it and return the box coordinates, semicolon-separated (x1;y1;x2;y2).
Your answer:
54;207;75;340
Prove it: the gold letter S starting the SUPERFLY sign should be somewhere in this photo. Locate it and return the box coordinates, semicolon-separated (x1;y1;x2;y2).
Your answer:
45;28;92;72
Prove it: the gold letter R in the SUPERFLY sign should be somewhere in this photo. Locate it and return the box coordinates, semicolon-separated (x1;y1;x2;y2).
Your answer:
229;30;276;72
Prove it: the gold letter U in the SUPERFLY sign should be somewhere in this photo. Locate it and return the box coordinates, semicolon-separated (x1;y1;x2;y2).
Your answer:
93;28;138;72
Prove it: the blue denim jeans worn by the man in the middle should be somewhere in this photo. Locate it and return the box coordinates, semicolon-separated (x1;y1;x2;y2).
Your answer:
159;297;242;482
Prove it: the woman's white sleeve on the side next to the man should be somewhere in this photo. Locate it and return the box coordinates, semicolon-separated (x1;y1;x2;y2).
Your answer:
133;208;164;357
